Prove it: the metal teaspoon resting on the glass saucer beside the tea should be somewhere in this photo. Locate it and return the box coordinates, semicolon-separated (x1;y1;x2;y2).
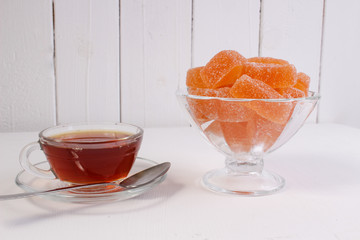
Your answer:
0;162;171;201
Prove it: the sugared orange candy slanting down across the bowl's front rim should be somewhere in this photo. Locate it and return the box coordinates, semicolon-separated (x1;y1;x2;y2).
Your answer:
230;75;292;124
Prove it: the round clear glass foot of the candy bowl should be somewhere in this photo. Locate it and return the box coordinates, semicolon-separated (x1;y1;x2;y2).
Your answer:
202;168;285;197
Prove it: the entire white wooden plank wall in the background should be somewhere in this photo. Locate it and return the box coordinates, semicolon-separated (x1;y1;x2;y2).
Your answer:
0;0;360;131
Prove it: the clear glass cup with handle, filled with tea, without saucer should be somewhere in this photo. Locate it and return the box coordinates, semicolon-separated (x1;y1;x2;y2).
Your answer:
20;123;143;184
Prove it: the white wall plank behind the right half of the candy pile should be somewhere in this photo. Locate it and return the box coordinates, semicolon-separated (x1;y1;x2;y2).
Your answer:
260;0;323;122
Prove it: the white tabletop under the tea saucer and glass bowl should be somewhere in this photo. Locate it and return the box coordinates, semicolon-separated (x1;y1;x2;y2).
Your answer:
0;124;360;240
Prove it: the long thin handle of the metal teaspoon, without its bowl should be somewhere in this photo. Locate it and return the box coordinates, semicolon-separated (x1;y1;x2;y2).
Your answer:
0;183;117;201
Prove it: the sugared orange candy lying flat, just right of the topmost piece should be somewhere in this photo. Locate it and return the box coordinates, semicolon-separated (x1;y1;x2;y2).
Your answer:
244;57;296;88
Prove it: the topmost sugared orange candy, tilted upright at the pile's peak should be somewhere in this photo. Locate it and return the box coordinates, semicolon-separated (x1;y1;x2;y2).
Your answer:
200;50;246;89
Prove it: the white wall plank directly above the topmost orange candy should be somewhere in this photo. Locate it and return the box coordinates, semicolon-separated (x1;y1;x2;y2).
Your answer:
192;0;260;67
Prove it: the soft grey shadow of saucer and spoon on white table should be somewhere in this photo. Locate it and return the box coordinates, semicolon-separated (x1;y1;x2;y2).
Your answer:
5;176;183;227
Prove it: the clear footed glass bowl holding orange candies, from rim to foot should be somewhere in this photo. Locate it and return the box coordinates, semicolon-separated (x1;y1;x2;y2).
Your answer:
177;91;320;196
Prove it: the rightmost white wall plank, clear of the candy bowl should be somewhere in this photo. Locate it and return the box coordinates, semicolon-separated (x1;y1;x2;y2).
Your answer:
319;0;360;127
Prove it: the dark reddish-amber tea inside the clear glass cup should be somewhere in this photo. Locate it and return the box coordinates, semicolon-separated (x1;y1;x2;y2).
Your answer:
40;130;142;183
